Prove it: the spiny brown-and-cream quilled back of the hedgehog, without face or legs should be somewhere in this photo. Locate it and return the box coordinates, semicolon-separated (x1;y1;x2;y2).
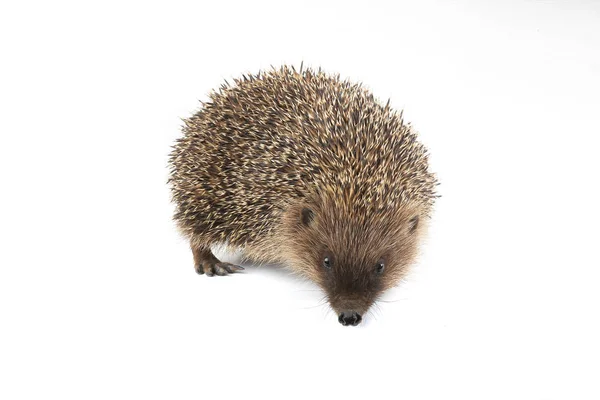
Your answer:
170;67;435;245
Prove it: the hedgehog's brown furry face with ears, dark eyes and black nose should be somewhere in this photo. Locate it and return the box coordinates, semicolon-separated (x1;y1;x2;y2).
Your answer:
290;202;420;326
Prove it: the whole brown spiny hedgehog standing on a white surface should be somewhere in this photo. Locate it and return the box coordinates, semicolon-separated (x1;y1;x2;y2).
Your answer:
169;66;437;326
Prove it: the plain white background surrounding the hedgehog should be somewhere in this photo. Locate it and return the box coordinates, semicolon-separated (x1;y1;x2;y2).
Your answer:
0;1;600;399
